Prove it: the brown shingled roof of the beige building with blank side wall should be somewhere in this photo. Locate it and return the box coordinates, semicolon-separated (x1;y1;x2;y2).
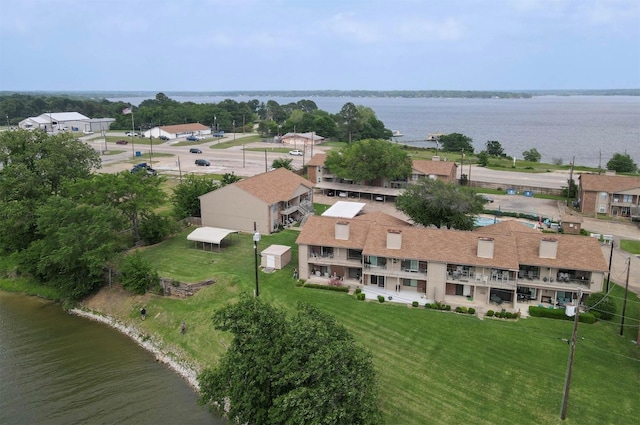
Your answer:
233;168;313;204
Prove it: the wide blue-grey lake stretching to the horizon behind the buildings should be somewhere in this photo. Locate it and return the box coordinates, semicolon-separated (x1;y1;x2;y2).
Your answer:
110;94;640;167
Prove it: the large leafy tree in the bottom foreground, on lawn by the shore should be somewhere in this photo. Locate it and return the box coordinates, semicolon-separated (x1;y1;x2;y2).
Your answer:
198;296;380;424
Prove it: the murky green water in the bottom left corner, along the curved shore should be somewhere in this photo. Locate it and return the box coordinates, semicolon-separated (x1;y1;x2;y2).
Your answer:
0;292;226;425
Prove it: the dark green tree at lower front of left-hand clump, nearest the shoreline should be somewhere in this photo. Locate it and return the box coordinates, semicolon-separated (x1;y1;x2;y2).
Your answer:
18;196;124;299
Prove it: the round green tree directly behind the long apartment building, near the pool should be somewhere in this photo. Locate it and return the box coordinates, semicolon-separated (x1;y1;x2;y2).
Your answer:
396;179;485;230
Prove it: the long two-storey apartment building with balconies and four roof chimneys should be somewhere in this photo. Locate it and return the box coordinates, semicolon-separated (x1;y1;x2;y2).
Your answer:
296;212;608;311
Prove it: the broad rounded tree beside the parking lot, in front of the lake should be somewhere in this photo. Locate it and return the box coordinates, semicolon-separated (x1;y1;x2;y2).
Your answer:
325;139;412;182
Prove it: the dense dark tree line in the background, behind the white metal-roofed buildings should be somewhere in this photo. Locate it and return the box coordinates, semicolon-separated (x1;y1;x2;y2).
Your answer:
0;93;391;141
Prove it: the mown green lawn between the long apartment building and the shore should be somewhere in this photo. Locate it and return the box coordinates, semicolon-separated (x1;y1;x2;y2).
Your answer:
130;229;640;424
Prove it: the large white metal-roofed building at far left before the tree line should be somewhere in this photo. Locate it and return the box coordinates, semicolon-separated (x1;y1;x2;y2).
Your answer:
18;112;115;133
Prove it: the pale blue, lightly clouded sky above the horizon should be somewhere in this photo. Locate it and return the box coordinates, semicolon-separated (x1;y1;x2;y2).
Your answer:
0;0;640;92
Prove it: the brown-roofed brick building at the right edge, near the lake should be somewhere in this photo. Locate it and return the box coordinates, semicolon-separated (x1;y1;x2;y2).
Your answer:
578;174;640;220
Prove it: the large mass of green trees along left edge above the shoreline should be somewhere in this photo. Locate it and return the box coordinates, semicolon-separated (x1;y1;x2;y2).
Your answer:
0;130;171;299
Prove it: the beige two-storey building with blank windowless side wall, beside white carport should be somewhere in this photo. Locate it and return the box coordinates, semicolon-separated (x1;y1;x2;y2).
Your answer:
200;168;313;235
